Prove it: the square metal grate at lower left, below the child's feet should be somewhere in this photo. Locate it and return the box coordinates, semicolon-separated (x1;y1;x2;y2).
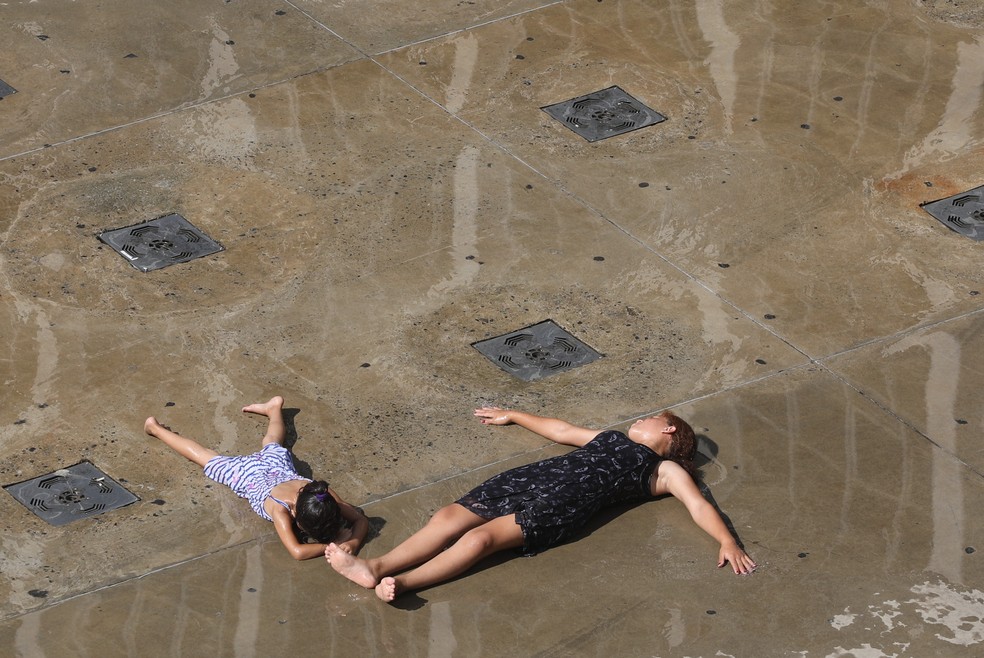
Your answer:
4;462;140;525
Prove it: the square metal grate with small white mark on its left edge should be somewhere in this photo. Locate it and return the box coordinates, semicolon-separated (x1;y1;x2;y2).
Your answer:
99;214;223;272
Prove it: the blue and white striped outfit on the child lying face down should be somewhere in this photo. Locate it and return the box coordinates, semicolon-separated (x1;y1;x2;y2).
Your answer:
205;443;311;521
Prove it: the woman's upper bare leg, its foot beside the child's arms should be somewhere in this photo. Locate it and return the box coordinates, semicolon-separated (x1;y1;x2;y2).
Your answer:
325;503;488;587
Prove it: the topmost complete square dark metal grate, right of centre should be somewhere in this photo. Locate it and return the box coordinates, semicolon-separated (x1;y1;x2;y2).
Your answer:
540;86;666;142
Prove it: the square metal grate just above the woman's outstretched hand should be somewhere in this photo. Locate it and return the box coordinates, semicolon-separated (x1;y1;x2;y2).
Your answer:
472;320;603;382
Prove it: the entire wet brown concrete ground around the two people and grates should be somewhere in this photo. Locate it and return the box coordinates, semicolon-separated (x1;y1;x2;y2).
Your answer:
0;0;984;656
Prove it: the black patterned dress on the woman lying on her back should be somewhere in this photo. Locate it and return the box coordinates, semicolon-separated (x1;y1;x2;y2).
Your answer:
456;430;663;555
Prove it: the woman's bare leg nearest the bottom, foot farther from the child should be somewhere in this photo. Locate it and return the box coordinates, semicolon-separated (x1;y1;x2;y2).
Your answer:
376;514;523;602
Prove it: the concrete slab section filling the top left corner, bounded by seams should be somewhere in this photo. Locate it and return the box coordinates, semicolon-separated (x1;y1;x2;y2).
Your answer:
0;0;362;156
